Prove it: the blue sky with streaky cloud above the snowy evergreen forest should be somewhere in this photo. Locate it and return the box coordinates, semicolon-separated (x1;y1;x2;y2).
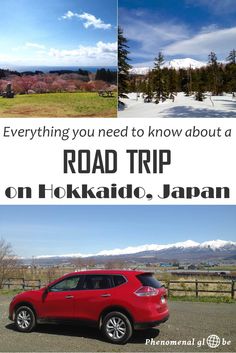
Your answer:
119;0;236;66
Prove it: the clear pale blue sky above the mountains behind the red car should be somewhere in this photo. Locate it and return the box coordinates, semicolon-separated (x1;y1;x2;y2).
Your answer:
0;206;236;257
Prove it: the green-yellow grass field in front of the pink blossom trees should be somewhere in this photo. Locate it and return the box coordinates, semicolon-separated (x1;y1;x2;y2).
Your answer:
0;92;117;118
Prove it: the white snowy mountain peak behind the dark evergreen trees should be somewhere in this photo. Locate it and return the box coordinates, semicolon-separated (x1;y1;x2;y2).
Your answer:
130;58;207;75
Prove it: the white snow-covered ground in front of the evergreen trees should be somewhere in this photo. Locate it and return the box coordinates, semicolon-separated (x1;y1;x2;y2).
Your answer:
118;93;236;118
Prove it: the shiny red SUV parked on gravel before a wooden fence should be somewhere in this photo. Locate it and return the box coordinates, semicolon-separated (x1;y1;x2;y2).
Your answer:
9;270;169;343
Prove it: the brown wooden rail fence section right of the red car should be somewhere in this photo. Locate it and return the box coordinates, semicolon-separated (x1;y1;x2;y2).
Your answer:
163;279;236;299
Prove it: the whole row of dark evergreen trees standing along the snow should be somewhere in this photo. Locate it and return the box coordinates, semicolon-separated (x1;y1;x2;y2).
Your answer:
118;28;236;104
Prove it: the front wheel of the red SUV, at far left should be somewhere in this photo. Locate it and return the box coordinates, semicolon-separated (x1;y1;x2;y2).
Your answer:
15;306;36;332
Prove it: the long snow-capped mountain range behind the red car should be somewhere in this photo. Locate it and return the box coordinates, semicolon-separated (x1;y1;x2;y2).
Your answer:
36;240;236;259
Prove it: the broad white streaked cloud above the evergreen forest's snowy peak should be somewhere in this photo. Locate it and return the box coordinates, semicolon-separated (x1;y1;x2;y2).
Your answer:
164;27;236;56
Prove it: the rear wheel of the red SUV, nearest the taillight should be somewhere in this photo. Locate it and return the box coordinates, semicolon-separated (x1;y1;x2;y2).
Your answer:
101;311;133;344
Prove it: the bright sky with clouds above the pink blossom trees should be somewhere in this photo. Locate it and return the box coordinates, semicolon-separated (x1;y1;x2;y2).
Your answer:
0;0;117;66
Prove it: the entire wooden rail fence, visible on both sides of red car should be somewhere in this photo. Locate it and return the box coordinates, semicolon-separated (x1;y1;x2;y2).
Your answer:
3;278;236;299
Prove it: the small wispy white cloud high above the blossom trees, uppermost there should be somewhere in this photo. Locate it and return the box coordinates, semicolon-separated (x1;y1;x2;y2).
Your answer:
59;10;112;29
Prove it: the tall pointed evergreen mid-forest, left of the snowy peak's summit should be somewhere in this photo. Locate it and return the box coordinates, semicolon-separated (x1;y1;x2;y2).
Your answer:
153;52;169;104
